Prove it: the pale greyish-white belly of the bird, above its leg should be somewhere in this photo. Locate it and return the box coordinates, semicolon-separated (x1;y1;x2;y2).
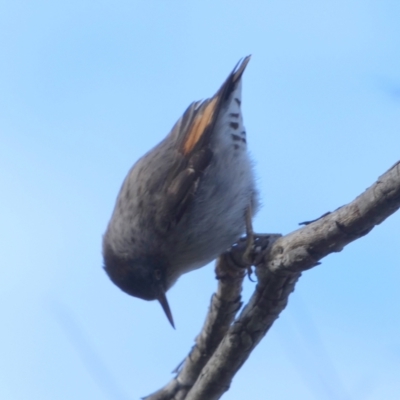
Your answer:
170;148;258;274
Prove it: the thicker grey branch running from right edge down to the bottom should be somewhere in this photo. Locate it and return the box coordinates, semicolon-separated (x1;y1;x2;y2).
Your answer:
149;162;400;400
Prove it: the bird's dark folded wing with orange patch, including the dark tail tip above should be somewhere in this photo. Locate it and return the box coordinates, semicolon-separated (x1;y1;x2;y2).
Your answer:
162;56;250;228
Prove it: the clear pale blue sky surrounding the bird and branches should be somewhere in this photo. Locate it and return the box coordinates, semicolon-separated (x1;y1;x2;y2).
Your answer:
0;0;400;400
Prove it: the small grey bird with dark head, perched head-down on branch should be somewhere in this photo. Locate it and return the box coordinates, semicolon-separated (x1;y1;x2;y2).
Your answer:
102;56;259;327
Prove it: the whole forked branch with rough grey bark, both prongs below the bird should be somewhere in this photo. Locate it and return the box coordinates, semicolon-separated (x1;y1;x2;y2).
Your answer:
146;161;400;400
